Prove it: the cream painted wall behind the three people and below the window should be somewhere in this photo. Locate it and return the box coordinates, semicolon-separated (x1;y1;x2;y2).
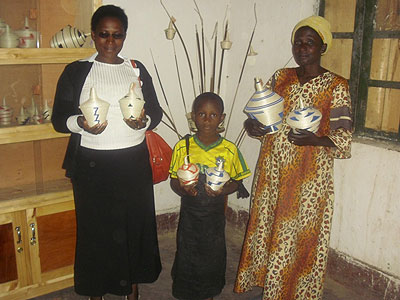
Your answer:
103;0;400;278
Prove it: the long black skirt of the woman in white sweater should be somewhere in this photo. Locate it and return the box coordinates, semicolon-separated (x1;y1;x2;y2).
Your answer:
72;142;161;296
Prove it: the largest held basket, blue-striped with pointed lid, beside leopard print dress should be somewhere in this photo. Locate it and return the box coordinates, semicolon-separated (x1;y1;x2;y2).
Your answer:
244;78;283;134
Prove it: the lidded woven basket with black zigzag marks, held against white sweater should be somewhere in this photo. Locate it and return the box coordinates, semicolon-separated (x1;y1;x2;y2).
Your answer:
79;88;110;127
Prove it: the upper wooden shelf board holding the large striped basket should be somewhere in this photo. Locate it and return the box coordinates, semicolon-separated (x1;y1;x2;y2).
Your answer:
0;48;96;65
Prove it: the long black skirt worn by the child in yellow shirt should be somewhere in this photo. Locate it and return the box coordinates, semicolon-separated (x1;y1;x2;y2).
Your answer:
171;176;226;300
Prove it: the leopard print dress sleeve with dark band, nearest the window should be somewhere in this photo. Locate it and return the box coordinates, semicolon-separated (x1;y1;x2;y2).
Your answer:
328;79;352;158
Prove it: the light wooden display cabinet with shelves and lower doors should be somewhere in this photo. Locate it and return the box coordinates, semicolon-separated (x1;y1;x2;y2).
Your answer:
0;0;101;300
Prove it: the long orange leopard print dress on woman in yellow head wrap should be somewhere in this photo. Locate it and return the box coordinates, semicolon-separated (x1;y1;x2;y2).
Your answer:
234;68;351;300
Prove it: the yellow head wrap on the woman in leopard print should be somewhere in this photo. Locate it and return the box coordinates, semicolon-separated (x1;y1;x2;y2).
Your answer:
292;16;332;54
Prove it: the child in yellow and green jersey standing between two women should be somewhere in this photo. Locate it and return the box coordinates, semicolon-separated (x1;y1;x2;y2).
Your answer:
170;93;250;300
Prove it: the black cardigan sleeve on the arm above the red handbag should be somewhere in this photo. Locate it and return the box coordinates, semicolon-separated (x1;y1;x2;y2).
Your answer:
135;60;163;130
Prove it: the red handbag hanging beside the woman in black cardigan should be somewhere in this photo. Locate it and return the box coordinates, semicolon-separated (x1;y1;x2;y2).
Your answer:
146;130;172;184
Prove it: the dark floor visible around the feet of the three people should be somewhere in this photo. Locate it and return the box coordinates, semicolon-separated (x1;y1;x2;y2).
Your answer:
30;224;380;300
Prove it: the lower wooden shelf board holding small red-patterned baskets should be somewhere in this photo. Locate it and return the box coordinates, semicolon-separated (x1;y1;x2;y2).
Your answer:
0;123;69;145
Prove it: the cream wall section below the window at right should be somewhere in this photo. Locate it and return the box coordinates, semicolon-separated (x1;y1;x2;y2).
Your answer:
331;143;400;278
